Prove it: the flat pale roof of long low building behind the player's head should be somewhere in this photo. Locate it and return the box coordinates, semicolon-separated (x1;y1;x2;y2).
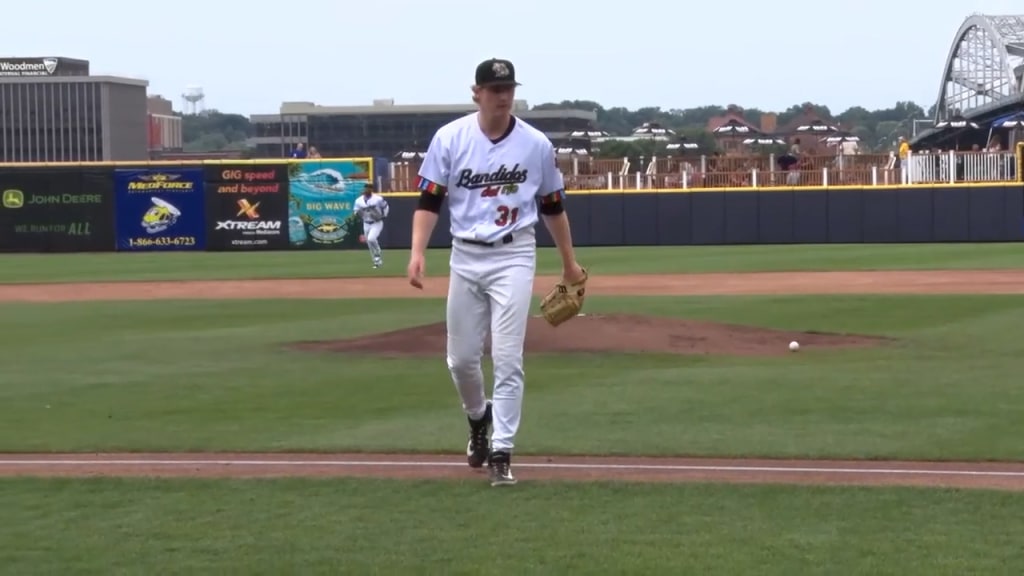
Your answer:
250;98;597;121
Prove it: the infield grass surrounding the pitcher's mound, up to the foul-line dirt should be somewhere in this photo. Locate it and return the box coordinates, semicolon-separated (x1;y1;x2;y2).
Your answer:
0;295;1024;459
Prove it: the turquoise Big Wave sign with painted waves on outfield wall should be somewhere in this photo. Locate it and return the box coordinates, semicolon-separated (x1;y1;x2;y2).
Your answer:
288;159;373;250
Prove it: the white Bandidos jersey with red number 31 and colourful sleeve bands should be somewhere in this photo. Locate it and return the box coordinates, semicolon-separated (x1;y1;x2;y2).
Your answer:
419;114;565;242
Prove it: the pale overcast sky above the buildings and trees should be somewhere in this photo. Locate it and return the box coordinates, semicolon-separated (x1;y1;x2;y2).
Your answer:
2;0;1024;115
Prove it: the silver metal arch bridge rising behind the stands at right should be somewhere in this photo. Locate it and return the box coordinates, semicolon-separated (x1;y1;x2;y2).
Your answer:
915;14;1024;142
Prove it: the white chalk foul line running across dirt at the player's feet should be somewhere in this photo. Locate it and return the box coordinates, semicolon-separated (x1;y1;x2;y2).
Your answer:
0;459;1024;478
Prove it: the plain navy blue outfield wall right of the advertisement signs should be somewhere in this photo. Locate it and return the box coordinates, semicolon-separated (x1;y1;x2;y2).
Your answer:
382;183;1024;248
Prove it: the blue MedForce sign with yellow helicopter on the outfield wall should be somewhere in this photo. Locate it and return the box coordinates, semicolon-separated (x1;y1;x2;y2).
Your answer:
114;168;206;251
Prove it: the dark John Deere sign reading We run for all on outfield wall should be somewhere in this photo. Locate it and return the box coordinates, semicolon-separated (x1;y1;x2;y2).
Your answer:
0;168;114;252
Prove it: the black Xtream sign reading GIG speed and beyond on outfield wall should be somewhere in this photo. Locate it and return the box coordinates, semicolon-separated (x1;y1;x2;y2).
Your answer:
206;164;288;250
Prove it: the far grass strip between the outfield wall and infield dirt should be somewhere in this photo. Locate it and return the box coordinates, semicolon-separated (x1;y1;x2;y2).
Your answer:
0;243;1024;284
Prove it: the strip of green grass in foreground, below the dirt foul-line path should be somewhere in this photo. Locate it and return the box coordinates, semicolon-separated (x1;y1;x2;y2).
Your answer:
0;479;1024;576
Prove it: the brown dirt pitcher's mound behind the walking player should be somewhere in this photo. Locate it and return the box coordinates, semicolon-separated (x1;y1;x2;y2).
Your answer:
293;315;885;356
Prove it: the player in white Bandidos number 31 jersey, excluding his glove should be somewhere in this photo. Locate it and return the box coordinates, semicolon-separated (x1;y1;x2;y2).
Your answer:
408;58;584;486
